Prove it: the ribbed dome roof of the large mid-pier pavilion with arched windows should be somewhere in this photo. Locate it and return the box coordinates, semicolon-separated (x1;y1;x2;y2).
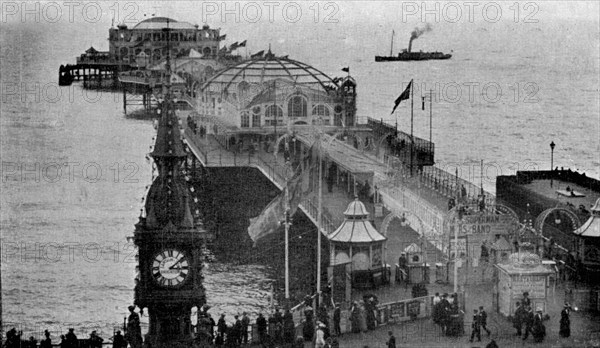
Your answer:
202;51;339;91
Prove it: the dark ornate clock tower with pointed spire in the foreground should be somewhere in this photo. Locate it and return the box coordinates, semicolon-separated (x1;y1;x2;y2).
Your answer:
134;69;210;348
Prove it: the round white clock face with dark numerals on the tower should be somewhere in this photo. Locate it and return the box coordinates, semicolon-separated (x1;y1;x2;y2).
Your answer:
152;249;190;287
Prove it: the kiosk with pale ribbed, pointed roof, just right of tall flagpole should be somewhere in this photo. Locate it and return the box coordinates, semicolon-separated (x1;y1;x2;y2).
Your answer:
327;198;389;287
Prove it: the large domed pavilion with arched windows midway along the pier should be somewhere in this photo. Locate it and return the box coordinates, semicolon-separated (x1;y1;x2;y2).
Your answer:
197;51;355;139
